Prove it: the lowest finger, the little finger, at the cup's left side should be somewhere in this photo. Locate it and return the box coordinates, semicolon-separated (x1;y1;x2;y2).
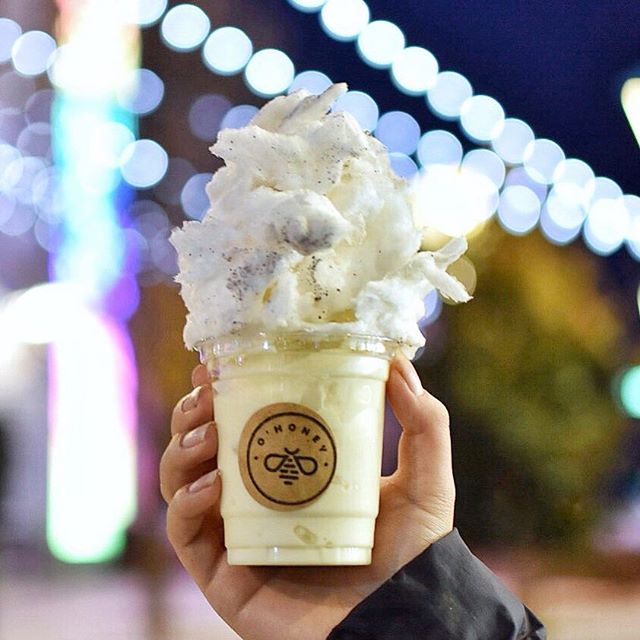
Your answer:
167;470;224;585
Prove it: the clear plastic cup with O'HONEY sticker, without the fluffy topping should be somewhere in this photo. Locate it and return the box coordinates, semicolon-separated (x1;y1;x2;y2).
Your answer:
199;332;397;565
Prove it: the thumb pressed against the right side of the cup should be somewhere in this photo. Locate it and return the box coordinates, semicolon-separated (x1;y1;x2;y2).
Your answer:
387;357;455;514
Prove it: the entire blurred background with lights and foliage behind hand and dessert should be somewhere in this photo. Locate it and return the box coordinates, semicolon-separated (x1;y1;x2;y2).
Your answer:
0;0;640;640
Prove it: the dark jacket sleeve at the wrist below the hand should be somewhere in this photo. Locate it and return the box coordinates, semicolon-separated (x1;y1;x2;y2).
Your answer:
327;529;547;640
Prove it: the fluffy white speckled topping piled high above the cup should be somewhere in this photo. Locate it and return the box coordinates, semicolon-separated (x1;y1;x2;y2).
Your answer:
171;84;469;355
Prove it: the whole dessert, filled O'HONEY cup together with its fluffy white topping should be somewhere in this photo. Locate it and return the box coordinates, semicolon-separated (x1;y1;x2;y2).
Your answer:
172;85;468;565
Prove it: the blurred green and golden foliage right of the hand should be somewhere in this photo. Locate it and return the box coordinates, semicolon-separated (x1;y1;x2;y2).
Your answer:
418;227;624;547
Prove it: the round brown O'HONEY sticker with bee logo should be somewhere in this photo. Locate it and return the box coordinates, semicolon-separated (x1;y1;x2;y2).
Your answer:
238;402;336;510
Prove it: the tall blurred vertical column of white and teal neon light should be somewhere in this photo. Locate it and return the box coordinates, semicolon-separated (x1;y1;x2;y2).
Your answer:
47;0;139;563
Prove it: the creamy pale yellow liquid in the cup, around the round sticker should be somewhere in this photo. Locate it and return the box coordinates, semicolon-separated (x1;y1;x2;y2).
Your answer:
214;349;389;564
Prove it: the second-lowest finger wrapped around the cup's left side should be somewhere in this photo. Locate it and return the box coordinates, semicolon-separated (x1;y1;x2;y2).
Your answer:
160;422;218;502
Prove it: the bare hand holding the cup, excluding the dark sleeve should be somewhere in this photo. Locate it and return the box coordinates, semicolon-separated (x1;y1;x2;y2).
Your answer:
160;358;455;640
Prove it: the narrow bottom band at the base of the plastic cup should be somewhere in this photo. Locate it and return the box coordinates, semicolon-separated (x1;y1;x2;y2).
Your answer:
227;547;371;566
